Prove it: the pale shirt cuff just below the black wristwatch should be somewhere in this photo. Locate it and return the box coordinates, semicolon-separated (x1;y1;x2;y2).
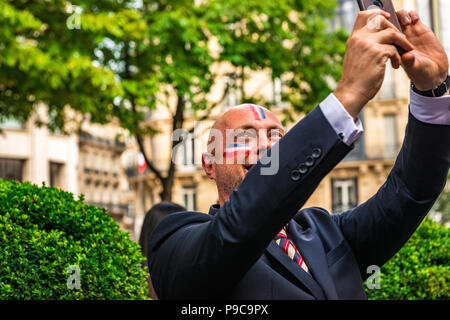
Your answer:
409;89;450;125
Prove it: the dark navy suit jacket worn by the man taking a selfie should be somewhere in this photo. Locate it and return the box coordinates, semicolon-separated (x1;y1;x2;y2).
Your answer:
148;107;450;299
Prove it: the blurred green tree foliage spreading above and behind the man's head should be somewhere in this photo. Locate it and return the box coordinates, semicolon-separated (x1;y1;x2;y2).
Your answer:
0;0;346;200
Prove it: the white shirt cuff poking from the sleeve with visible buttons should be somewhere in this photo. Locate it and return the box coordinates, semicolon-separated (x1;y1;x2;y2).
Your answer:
320;93;364;145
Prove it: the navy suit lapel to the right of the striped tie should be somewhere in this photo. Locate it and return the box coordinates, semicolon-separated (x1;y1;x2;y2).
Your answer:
288;215;338;300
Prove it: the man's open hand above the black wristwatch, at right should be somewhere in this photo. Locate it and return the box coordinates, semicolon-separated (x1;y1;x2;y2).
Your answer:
397;10;449;91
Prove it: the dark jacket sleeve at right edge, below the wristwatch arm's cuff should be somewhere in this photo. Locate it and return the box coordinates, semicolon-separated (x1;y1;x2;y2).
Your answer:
332;113;450;279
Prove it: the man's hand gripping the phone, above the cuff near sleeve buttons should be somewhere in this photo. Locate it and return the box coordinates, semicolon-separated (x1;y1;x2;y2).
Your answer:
334;10;414;118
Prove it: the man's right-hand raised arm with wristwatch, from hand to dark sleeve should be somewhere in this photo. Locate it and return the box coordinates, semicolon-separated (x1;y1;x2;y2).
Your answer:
333;10;450;278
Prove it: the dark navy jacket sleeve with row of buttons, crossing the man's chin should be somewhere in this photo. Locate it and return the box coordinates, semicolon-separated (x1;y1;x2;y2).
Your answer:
149;107;351;299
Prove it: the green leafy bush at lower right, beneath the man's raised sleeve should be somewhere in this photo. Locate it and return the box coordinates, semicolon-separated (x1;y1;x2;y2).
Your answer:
366;218;450;300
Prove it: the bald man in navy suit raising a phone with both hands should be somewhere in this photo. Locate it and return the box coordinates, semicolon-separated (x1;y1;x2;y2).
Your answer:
148;10;450;299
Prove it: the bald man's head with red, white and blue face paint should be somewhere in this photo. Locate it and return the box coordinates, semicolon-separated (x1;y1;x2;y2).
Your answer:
203;104;284;204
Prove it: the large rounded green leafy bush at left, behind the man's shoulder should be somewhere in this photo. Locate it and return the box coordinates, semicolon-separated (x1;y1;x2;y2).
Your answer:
0;180;147;299
